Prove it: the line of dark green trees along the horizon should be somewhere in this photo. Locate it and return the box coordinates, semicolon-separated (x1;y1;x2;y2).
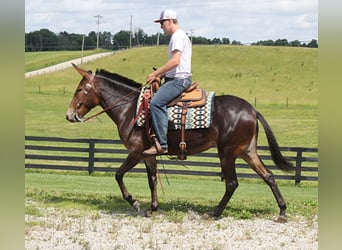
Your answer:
25;28;318;52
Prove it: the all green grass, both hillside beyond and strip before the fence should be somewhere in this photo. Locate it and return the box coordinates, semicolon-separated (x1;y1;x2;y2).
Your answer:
25;46;318;222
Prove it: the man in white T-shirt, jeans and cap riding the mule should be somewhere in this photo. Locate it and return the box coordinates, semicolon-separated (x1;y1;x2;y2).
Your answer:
144;10;192;155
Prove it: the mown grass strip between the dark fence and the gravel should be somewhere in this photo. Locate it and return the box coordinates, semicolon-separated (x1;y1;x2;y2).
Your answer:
25;171;318;220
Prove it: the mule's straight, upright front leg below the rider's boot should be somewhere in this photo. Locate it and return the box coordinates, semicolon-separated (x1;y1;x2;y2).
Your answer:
145;157;158;217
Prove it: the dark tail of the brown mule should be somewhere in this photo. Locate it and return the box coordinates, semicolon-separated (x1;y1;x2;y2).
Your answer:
256;111;295;172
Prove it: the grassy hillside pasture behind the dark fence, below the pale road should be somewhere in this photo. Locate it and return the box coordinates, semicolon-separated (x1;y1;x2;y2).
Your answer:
25;46;318;147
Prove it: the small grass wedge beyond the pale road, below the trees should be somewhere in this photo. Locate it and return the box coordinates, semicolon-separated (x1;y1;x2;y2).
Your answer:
25;49;111;72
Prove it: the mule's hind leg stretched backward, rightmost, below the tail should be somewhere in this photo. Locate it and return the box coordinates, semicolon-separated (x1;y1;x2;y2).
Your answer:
241;149;287;223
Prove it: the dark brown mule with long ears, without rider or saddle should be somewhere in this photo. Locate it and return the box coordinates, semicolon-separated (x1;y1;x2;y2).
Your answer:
66;64;294;223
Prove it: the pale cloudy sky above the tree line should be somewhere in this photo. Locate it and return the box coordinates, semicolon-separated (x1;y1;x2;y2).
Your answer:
25;0;318;44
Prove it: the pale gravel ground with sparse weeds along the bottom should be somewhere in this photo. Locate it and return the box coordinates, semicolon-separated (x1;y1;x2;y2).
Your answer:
25;203;318;250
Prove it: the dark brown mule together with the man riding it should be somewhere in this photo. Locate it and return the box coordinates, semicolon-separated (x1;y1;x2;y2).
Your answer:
66;10;294;222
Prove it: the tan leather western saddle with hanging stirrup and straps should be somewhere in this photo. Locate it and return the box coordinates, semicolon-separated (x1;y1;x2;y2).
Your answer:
134;81;207;160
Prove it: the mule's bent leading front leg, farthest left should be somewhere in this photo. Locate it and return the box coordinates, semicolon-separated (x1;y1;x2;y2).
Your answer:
115;151;142;212
